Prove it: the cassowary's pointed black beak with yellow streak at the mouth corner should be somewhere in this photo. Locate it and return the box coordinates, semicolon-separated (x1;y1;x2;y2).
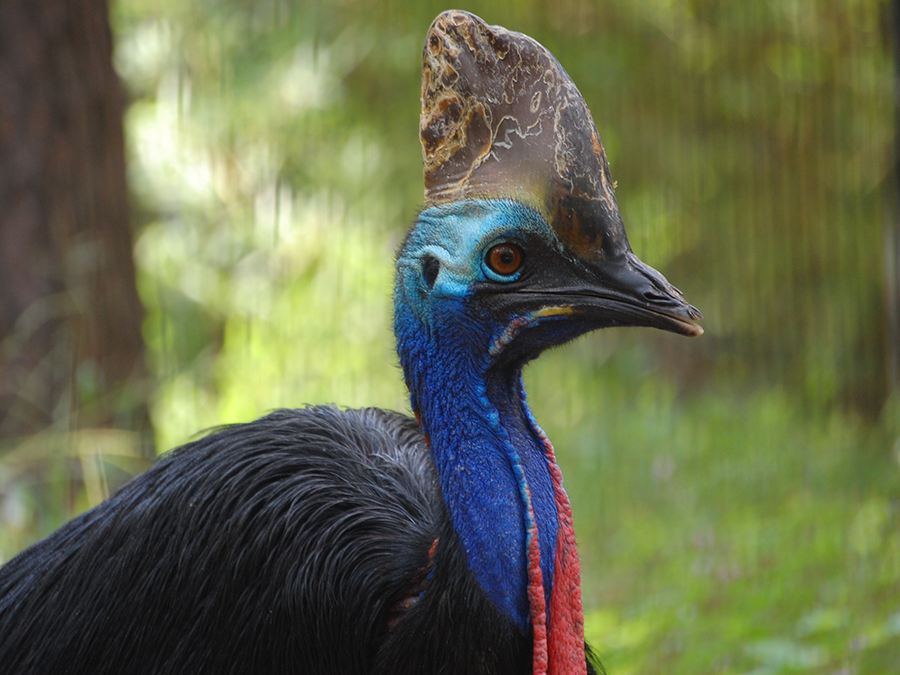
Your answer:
479;248;703;337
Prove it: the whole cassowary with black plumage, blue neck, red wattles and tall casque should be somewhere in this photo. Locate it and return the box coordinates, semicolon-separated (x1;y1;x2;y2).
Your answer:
0;11;702;675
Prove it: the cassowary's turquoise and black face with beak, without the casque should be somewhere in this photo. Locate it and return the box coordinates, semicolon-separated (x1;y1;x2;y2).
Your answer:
394;199;703;375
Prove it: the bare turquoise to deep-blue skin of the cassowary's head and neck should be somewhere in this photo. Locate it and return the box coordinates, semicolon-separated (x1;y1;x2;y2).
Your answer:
394;200;561;632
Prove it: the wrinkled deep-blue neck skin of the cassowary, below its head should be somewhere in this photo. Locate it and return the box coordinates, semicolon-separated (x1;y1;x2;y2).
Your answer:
398;294;556;631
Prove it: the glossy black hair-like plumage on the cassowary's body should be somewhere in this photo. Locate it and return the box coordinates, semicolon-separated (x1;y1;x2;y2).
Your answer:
0;406;596;675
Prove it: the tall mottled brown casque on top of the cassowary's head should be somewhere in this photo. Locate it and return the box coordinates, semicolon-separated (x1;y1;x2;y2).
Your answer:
419;10;630;259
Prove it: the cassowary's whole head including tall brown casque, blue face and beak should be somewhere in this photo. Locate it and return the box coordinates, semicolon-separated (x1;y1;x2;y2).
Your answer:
395;11;703;375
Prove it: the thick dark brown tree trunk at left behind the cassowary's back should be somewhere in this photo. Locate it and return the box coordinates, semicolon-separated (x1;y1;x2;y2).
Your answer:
0;0;153;486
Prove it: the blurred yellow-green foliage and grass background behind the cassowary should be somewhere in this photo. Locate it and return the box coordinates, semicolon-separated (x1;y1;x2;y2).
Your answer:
0;0;900;675
